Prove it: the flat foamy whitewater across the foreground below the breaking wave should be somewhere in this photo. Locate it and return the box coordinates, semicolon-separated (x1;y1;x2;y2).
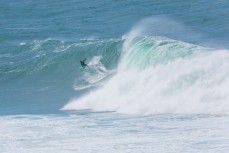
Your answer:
0;112;229;153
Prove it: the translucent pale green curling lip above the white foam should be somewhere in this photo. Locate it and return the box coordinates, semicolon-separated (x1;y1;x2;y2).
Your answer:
120;37;210;70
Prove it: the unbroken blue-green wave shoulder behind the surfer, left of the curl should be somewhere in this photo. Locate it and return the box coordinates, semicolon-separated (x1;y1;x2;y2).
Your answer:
0;39;122;83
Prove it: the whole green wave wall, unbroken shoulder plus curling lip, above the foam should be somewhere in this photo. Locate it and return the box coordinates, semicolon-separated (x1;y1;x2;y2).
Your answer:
0;37;209;79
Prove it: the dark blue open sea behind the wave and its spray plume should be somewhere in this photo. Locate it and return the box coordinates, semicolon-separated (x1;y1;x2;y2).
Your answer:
1;0;229;40
